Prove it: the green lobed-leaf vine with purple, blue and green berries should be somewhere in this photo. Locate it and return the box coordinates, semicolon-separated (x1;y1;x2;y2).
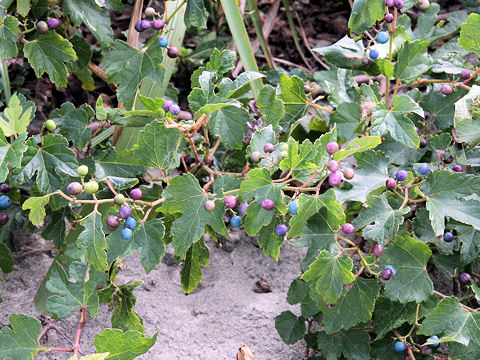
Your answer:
0;0;480;360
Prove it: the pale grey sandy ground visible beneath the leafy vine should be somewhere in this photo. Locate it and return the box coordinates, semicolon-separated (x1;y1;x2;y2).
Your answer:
0;232;305;360
